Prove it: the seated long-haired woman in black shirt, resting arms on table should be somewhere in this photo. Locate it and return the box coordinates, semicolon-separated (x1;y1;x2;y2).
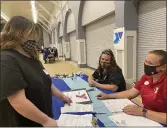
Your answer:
89;49;126;92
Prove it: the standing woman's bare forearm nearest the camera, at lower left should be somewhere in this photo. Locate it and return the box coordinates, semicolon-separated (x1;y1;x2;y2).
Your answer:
8;91;56;126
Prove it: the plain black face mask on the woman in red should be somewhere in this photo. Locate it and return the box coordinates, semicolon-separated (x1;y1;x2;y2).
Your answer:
144;63;162;76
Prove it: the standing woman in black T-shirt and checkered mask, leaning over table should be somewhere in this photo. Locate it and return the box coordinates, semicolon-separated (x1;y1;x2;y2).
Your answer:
0;16;71;127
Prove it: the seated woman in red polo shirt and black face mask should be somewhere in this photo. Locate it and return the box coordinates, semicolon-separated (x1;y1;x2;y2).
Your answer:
97;50;167;124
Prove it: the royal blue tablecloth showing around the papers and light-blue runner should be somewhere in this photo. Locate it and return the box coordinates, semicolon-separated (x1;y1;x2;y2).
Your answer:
52;75;114;127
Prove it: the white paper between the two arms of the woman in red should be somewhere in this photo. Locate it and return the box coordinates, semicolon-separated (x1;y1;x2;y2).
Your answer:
102;99;135;113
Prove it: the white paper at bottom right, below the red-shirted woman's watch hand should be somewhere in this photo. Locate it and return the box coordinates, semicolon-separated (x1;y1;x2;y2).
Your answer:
109;112;162;126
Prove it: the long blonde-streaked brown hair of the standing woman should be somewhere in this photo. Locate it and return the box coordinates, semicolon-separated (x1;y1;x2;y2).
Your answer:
0;16;41;59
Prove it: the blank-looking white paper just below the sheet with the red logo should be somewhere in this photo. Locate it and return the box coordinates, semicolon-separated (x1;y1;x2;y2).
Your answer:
61;103;93;113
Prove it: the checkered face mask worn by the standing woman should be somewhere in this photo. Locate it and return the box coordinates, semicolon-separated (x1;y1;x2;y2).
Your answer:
22;40;36;53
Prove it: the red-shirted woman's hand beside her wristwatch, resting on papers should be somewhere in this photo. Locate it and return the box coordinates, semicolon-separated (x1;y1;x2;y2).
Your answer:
123;105;143;116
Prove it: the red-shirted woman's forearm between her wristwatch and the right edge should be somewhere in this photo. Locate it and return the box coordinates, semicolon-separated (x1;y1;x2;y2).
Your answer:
146;110;167;124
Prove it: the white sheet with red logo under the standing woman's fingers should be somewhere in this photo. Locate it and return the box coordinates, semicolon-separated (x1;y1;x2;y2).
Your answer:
64;90;90;103
